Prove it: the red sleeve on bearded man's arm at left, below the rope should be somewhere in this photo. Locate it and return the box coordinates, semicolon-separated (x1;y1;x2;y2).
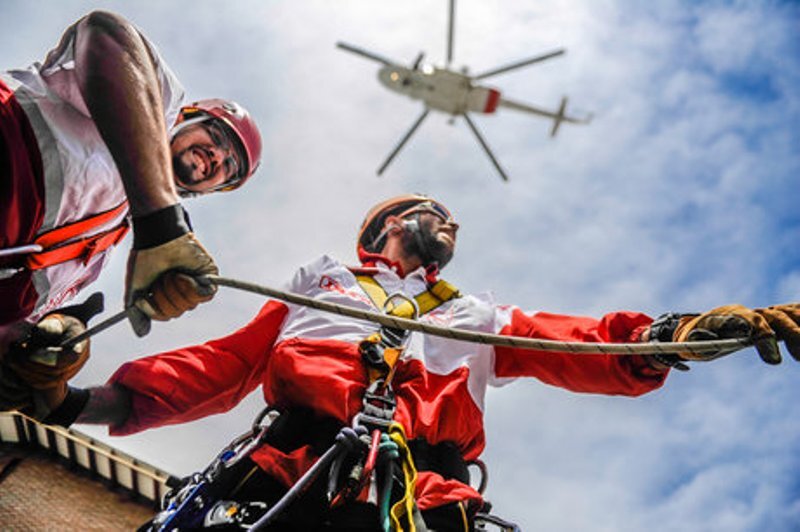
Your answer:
109;301;288;436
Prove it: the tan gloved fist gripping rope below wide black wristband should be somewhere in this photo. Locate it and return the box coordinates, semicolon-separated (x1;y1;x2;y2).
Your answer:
125;233;219;336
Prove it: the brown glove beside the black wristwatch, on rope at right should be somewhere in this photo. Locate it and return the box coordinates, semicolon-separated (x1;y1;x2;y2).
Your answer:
673;305;780;364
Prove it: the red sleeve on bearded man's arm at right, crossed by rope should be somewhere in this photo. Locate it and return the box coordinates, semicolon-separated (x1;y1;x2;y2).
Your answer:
495;309;668;396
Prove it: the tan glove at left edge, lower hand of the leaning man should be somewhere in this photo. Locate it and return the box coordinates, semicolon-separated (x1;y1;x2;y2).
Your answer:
3;313;89;420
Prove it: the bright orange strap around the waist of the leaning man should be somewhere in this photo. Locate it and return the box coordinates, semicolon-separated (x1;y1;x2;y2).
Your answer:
25;201;130;270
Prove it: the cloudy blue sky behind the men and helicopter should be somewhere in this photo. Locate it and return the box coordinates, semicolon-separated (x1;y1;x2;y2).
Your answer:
0;0;800;532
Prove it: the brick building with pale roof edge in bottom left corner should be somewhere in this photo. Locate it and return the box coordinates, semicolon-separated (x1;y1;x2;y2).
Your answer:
0;413;169;532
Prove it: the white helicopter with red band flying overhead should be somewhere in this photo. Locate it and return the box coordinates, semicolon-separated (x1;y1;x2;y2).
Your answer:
336;0;592;181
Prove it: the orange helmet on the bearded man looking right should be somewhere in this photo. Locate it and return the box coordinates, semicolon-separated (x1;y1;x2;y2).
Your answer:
356;194;453;257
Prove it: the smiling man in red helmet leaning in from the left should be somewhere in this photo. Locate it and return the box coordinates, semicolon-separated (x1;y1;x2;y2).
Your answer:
0;11;261;357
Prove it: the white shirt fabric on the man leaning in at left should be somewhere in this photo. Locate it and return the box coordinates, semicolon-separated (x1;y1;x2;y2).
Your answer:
0;15;184;338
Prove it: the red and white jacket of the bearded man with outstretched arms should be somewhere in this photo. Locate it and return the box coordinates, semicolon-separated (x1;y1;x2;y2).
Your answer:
110;256;666;509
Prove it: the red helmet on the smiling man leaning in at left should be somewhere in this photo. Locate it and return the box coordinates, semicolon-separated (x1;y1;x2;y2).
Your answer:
177;98;261;190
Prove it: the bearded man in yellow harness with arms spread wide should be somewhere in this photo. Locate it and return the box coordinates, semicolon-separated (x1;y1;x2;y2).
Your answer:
7;195;800;530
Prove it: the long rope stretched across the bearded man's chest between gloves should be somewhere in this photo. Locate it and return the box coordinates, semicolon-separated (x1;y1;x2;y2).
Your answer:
205;275;752;355
